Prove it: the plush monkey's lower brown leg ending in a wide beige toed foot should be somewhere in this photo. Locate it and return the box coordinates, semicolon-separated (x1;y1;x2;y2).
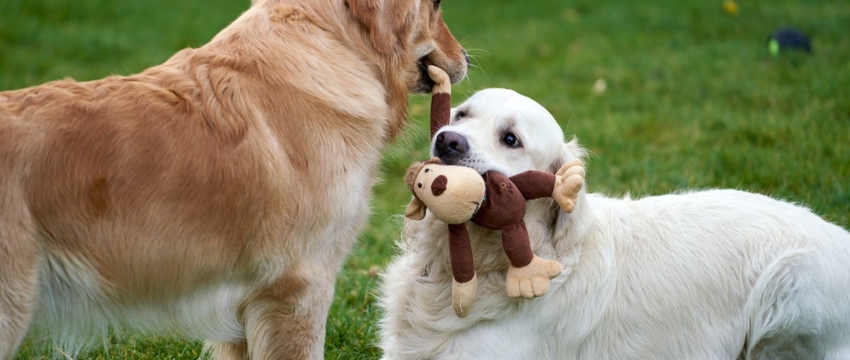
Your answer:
502;222;562;298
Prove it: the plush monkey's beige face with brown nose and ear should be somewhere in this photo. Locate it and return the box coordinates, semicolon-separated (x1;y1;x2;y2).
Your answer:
404;162;485;224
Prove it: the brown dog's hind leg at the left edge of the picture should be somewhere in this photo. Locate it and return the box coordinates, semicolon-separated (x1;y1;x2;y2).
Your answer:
0;204;40;360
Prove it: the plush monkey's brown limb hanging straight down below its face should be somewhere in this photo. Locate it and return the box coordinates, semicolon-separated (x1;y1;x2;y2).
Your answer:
449;224;478;317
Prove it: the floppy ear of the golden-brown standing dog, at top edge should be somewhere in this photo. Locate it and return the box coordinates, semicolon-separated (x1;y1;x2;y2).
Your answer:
345;0;420;54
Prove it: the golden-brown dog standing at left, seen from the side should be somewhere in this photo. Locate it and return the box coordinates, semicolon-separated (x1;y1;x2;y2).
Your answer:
0;0;467;359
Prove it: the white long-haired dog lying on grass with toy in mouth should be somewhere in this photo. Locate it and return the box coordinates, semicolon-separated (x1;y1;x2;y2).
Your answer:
381;89;850;359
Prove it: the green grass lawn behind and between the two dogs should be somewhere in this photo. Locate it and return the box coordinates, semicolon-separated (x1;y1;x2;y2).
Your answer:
0;0;850;359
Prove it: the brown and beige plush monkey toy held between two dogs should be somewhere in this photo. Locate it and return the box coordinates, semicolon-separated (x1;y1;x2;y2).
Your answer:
405;66;584;317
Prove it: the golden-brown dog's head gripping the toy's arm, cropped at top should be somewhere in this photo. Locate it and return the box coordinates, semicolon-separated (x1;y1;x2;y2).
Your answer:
346;0;469;93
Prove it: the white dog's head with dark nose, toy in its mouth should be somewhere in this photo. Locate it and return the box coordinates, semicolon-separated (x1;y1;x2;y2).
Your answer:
431;89;583;176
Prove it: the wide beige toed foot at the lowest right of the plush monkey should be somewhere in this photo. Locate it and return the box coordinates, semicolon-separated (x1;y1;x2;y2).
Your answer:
505;255;563;299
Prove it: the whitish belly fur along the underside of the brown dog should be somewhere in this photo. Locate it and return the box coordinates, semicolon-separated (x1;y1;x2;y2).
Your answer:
34;249;248;354
